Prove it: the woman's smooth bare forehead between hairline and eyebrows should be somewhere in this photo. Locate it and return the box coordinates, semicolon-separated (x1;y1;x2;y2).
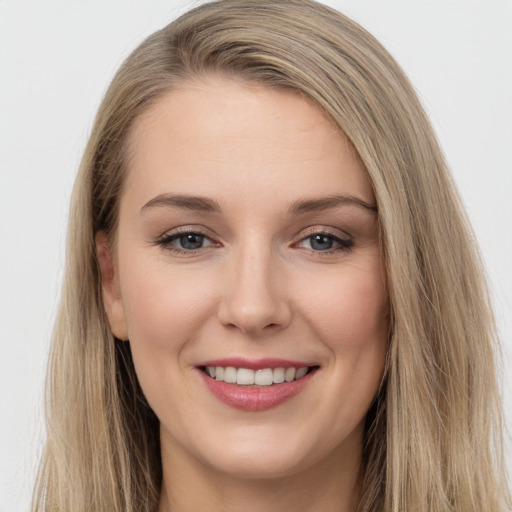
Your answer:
125;78;374;208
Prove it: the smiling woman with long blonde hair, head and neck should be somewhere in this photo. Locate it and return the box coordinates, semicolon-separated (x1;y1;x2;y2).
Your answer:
34;0;509;512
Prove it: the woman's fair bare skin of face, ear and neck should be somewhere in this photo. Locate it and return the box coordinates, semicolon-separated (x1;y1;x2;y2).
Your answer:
97;77;389;512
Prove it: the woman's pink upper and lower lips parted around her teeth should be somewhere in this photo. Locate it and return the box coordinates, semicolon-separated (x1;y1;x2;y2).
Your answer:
198;359;316;411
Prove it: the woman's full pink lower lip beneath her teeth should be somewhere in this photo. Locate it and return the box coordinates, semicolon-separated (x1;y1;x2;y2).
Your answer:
198;370;316;411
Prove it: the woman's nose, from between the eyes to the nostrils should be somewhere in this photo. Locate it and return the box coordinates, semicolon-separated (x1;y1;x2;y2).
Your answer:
218;246;291;337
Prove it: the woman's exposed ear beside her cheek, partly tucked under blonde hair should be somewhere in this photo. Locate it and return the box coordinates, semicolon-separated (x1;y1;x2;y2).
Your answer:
96;231;128;340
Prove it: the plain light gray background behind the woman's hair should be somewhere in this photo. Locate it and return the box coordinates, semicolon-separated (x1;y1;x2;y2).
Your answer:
0;0;512;512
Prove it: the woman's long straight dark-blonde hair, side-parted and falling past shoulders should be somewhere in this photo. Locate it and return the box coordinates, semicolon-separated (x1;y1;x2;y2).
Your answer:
33;0;510;512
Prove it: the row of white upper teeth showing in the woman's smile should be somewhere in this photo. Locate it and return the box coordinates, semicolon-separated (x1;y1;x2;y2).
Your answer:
205;366;309;386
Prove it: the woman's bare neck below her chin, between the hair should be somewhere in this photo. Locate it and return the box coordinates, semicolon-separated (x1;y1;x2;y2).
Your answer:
158;426;362;512
